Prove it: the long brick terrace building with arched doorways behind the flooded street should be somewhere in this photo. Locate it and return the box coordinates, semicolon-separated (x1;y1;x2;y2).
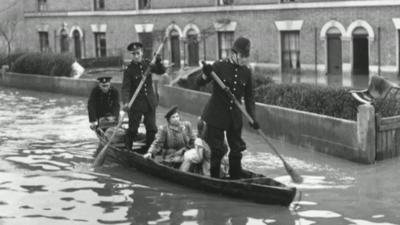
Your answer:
18;0;400;83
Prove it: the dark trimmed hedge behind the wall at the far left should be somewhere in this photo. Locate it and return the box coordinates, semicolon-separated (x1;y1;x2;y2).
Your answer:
11;53;75;76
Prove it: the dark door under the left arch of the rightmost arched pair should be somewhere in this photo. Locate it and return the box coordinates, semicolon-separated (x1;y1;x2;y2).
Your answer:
328;35;342;74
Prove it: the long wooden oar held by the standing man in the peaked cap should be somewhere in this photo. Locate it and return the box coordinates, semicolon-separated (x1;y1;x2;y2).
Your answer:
93;36;167;166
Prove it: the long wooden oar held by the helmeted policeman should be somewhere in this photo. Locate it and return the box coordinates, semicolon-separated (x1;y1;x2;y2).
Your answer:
202;61;303;183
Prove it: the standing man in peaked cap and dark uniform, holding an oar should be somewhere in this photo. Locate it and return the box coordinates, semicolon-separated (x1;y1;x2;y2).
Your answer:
122;42;165;149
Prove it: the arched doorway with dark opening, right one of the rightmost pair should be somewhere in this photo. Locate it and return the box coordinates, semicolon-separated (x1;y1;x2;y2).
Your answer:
352;27;369;75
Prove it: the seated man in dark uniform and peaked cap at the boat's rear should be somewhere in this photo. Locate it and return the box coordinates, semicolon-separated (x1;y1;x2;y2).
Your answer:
88;77;120;129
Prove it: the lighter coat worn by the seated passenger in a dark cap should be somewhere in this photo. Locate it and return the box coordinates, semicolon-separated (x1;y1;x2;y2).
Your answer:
148;121;196;155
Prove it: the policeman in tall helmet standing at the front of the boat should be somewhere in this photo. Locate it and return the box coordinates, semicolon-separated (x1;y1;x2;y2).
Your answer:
197;37;259;179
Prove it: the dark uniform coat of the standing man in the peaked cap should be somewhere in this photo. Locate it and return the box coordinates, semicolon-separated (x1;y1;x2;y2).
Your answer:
122;60;165;112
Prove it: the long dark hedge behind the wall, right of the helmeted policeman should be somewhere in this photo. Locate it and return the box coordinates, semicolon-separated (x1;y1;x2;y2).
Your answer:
255;84;360;120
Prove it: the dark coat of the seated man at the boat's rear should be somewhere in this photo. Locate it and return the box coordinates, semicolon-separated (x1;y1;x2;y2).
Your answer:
88;86;120;122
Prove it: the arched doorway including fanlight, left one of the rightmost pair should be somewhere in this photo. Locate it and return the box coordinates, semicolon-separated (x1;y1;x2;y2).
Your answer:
326;27;342;74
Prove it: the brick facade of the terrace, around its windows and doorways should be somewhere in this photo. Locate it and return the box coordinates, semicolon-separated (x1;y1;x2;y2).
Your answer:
20;0;400;76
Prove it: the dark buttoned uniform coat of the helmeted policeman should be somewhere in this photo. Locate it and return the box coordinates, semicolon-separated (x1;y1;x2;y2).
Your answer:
197;59;255;130
